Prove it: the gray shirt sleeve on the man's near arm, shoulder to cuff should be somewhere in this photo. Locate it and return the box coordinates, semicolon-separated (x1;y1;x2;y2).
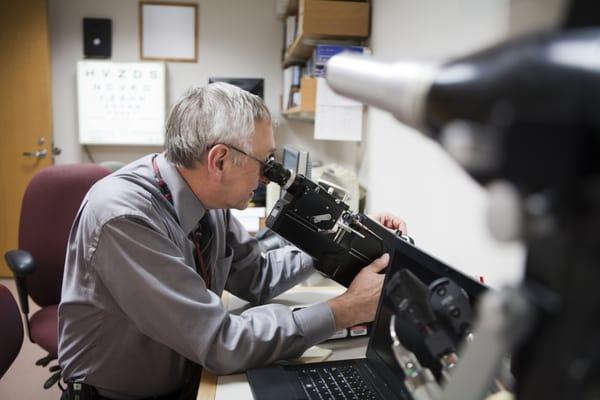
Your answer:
90;216;335;374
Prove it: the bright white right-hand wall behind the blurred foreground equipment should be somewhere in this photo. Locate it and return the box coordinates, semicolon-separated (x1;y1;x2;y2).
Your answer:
360;0;523;285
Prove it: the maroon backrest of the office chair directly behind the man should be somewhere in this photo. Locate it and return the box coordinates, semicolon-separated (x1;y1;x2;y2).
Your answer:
19;164;110;307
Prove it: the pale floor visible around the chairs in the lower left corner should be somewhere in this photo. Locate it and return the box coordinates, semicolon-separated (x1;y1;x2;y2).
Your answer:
0;278;61;400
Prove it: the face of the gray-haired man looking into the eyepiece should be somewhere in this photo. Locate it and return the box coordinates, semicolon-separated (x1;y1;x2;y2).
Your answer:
226;120;275;210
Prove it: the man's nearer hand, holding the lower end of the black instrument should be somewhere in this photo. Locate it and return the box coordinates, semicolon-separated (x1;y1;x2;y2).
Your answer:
328;254;390;329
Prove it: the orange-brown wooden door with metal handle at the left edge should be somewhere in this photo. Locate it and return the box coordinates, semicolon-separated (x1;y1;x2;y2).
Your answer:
0;0;52;277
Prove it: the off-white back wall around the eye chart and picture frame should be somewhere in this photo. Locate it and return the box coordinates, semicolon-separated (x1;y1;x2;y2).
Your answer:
49;0;360;168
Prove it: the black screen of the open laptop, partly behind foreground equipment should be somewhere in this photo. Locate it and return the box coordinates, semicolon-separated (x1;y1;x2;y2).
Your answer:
367;241;485;393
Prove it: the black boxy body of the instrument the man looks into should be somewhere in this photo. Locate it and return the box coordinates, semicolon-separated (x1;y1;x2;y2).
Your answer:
266;170;384;287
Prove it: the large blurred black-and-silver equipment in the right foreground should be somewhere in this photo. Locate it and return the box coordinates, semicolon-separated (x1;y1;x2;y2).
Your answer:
327;10;600;400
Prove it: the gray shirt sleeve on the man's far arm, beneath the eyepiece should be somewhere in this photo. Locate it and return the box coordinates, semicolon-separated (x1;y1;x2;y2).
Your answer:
225;214;314;304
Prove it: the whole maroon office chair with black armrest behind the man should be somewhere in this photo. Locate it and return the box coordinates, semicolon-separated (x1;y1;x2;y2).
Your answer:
4;164;110;388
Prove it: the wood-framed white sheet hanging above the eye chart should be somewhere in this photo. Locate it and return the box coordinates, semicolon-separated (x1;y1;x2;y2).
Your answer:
139;1;198;62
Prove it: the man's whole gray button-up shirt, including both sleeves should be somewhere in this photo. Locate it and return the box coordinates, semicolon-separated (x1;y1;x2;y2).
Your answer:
58;154;335;399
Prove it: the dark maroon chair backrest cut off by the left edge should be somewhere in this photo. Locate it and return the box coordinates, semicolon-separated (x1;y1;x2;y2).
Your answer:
0;284;23;379
